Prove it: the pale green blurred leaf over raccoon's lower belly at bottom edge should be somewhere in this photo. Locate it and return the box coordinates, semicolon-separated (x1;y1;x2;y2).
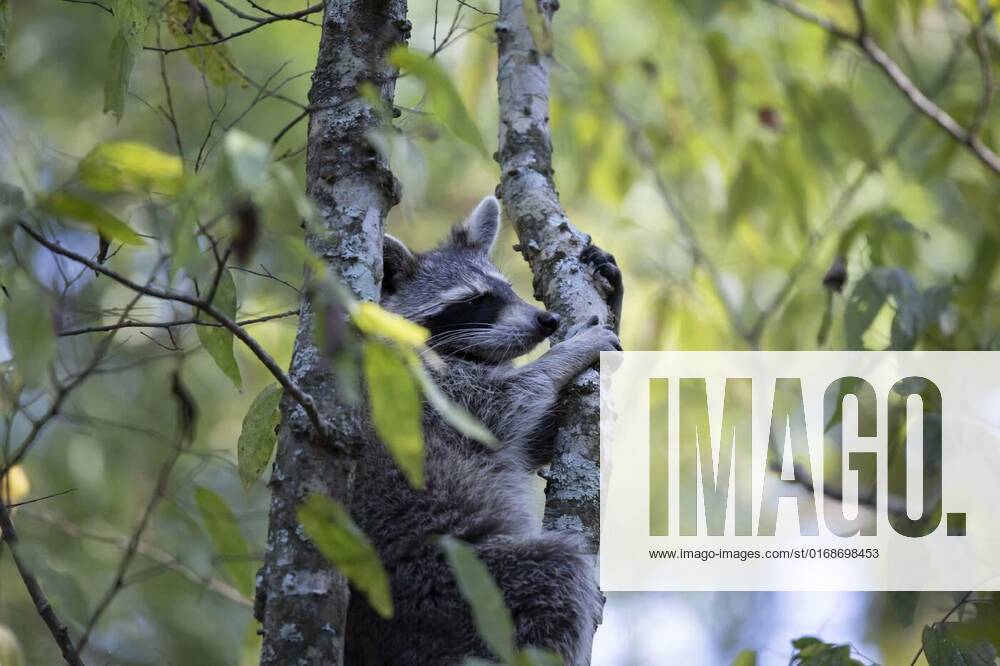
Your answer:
439;536;515;664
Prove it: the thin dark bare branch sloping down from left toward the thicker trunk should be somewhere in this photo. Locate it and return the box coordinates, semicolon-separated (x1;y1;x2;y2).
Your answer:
19;223;336;445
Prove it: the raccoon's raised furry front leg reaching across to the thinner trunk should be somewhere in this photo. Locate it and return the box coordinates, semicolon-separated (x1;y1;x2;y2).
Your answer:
498;317;621;462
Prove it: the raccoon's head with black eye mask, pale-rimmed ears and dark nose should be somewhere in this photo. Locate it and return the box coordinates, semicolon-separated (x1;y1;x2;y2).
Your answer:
382;197;559;363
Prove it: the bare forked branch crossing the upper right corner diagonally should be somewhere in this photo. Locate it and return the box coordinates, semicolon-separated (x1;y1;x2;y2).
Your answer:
767;0;1000;174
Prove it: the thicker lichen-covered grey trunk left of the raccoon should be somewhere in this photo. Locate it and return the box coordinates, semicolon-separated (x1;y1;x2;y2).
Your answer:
256;0;409;666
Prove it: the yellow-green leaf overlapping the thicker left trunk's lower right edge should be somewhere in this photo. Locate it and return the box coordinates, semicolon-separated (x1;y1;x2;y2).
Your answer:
298;495;392;618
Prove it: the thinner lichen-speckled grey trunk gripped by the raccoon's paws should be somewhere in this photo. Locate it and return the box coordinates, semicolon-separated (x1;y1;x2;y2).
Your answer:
496;0;617;554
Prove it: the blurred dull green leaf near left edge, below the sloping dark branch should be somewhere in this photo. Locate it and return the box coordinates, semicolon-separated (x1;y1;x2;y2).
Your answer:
6;280;56;386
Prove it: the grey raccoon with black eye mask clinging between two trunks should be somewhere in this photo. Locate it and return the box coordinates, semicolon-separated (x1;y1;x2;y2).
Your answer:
346;197;621;666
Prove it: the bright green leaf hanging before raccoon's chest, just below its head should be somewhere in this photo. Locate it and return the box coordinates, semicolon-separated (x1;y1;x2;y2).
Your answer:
361;339;424;488
